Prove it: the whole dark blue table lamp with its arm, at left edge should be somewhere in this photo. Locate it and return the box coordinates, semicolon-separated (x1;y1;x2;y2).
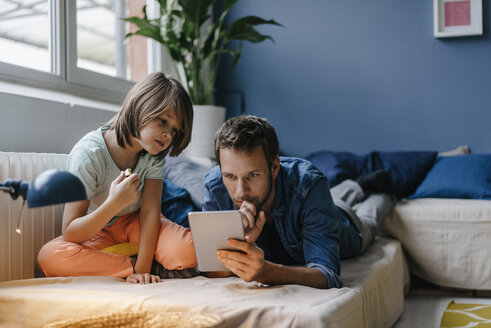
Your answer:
0;169;87;234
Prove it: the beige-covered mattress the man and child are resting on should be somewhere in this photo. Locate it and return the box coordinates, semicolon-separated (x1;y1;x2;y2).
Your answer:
0;238;409;328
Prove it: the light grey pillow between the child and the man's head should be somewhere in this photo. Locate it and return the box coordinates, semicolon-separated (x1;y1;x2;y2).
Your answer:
164;155;210;209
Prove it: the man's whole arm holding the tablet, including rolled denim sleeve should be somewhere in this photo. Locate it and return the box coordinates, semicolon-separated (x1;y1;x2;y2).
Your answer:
217;179;348;288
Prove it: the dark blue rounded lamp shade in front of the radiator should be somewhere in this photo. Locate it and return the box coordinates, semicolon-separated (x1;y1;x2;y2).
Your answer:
26;169;87;208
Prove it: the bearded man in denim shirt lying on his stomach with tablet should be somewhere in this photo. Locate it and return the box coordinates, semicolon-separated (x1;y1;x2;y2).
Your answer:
203;115;394;288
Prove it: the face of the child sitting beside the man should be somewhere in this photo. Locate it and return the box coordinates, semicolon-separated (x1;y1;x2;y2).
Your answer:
138;110;180;155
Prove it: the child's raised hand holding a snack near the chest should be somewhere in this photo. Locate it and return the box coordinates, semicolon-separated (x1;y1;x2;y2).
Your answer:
107;172;140;208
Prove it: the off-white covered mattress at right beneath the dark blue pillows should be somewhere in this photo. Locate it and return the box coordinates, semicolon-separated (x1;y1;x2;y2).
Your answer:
384;198;491;289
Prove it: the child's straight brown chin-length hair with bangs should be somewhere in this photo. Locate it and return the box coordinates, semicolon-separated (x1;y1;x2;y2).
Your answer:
108;72;193;158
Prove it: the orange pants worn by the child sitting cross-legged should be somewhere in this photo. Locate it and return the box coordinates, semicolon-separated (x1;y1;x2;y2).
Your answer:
38;211;197;278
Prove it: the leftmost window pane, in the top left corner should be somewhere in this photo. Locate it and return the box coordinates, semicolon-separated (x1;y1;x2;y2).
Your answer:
0;0;51;72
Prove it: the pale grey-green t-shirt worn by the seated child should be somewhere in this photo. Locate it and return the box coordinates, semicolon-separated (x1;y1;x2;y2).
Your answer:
66;125;165;223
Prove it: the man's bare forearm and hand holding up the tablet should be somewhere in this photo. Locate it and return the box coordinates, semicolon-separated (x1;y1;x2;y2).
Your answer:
217;239;328;288
